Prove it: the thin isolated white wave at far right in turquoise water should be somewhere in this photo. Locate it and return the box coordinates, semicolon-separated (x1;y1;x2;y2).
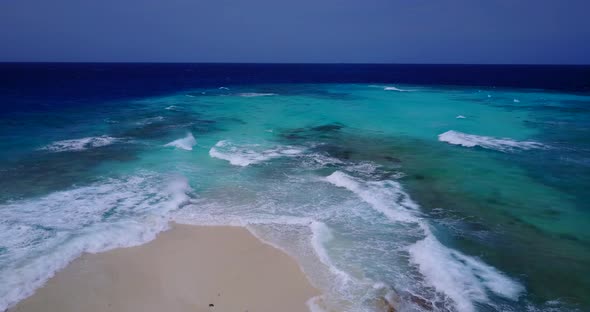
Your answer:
438;130;547;152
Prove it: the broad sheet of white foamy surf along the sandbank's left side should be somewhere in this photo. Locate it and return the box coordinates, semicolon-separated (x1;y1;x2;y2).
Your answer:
0;174;190;311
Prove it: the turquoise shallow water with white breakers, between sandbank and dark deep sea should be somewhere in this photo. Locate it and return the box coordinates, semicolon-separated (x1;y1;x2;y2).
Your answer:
0;84;590;312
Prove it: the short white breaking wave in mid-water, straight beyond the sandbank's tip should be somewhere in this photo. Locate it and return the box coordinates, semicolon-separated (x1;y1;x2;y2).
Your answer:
209;140;303;167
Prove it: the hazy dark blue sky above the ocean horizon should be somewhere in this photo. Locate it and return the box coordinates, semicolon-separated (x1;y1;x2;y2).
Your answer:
0;0;590;64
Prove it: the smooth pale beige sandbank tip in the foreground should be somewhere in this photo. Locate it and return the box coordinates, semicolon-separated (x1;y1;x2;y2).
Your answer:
9;225;319;312
